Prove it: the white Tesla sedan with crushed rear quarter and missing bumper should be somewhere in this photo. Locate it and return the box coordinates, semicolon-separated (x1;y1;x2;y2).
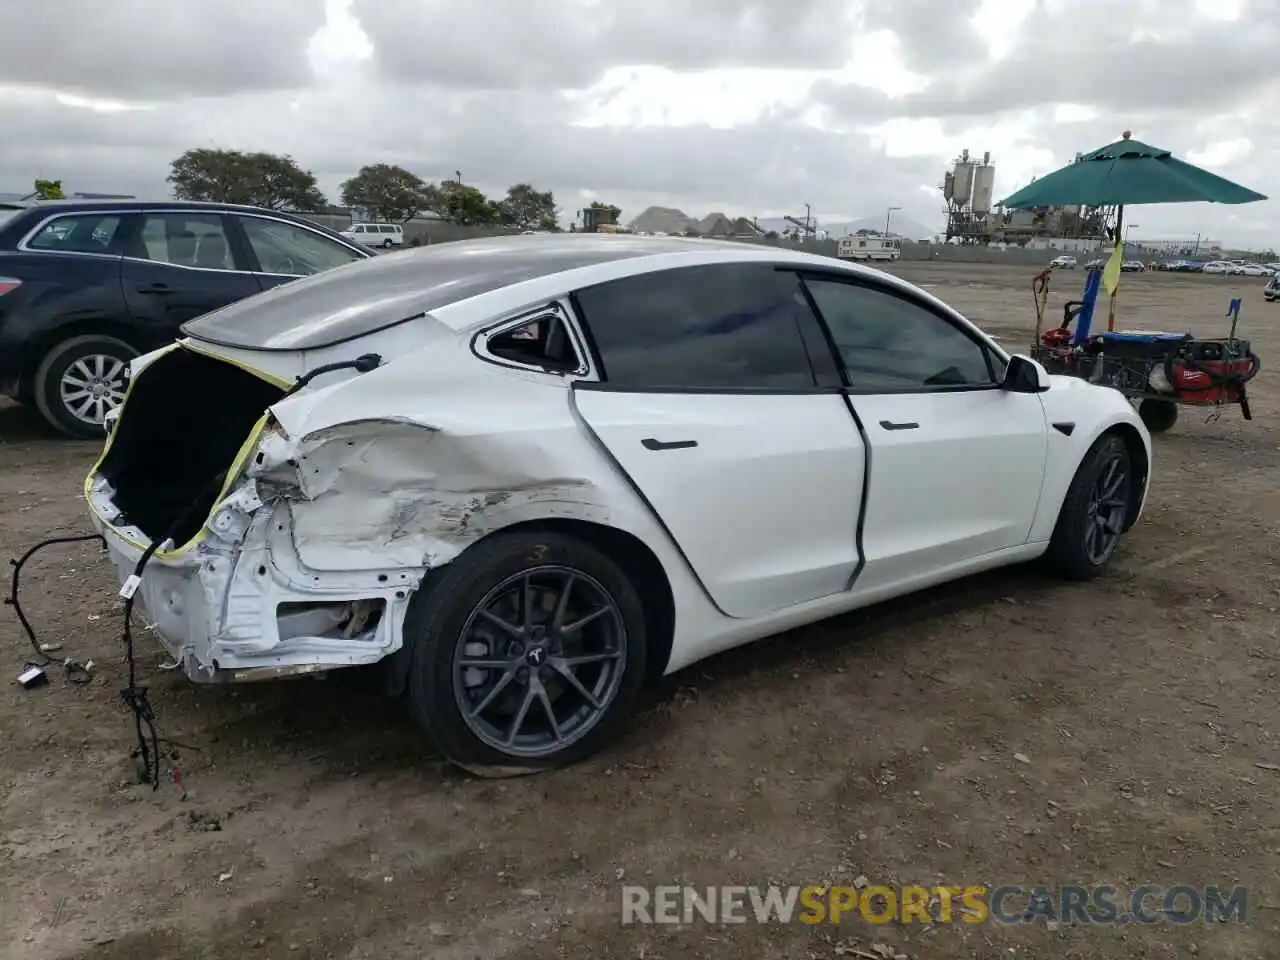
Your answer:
84;236;1151;772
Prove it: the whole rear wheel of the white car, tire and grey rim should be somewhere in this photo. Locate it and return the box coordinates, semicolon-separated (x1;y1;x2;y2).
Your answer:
404;532;646;777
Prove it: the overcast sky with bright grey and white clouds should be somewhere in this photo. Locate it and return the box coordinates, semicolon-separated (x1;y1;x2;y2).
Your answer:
0;0;1280;244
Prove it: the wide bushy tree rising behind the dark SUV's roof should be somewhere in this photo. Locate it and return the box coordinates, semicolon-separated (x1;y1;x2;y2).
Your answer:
169;147;328;212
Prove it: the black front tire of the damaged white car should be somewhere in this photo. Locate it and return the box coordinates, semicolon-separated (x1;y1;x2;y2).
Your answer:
1046;434;1134;580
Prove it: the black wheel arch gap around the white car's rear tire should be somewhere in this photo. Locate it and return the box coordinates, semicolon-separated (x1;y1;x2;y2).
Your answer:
387;517;676;696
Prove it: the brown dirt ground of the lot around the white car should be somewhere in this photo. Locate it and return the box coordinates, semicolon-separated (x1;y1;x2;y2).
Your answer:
0;264;1280;960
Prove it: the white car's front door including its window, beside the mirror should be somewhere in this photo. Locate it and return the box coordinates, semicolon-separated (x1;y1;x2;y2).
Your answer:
805;275;1049;593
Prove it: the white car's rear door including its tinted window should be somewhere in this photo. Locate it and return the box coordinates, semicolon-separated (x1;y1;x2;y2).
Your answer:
573;264;865;617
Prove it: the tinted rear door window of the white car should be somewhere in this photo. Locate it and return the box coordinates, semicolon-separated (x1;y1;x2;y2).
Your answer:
577;264;814;389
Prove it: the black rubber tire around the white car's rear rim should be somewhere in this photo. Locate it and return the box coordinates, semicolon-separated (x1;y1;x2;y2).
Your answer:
404;532;646;777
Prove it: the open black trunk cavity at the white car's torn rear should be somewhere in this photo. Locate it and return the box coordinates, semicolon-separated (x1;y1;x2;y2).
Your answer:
99;347;284;544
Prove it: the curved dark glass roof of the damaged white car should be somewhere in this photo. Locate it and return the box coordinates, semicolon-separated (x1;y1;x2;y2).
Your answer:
183;233;879;349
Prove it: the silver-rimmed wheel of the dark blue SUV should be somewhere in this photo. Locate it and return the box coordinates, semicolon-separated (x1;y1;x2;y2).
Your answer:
35;334;138;439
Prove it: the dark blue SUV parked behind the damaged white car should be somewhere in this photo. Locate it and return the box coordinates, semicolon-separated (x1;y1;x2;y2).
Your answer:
0;200;372;438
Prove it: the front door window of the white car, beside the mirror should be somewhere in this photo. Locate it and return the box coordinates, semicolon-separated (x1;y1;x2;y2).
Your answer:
805;278;996;392
